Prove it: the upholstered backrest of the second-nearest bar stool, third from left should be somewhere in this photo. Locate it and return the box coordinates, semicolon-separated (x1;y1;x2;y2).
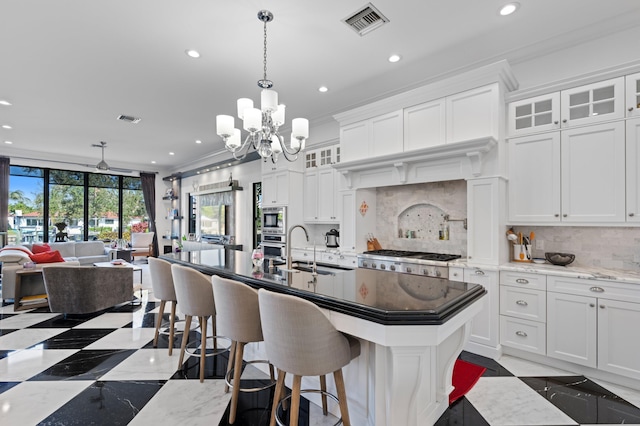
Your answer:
211;275;263;343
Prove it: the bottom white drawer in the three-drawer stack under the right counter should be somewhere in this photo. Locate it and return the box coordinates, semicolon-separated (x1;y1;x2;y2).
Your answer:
500;315;547;355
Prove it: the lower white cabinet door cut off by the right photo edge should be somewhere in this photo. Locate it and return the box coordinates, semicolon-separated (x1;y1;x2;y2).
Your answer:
598;299;640;379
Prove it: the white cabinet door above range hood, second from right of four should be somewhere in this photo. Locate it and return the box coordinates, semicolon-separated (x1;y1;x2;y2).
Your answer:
404;98;446;151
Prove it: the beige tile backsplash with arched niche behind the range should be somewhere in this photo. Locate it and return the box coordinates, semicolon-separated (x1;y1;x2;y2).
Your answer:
375;180;467;257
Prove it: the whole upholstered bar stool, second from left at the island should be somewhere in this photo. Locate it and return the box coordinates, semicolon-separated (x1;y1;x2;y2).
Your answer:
171;265;228;382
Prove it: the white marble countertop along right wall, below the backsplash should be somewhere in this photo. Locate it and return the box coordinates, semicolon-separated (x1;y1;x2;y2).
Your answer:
448;259;640;284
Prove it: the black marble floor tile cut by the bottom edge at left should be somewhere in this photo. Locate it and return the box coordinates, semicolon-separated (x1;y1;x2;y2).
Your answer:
39;380;165;426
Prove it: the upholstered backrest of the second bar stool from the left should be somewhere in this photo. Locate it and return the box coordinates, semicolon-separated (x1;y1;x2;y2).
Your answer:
171;264;216;316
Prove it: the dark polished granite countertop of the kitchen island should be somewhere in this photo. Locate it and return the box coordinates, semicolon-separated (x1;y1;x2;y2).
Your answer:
160;249;486;325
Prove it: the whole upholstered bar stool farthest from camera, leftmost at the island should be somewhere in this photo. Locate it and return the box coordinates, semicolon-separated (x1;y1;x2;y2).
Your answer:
149;257;177;355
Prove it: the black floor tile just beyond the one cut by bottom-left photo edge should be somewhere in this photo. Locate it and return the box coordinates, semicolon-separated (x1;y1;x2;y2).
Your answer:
29;349;135;381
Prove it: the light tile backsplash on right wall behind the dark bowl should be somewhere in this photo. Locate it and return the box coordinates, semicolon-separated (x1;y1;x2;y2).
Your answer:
505;226;640;272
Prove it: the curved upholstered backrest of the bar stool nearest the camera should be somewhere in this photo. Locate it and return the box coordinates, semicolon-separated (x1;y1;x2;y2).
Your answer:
258;289;351;376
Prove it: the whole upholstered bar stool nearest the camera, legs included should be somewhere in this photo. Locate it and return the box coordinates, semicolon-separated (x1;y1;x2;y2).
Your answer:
258;289;360;426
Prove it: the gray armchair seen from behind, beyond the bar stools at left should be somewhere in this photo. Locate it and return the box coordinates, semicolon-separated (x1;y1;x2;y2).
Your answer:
42;266;133;314
